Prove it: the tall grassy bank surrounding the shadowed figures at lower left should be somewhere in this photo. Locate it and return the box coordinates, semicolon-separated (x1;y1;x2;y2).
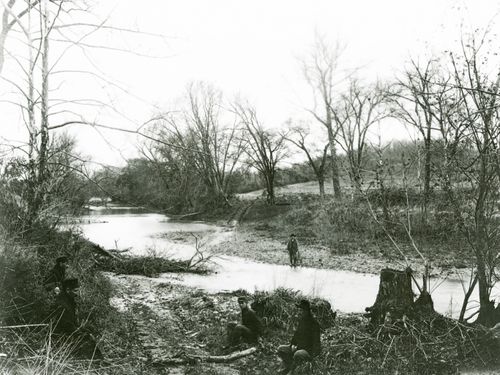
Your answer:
0;232;170;375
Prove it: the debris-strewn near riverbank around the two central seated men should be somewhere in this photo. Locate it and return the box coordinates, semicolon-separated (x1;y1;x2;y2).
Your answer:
103;274;494;375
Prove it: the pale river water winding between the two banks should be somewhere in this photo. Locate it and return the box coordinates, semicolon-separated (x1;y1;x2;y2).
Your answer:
80;207;488;317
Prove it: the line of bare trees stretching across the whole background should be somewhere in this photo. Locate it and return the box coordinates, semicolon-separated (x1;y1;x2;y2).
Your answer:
0;0;500;328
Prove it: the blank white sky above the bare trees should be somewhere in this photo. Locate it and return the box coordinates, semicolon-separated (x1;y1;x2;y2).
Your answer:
0;0;500;166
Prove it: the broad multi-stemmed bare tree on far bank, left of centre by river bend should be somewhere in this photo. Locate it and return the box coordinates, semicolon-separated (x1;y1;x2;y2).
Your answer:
143;83;244;209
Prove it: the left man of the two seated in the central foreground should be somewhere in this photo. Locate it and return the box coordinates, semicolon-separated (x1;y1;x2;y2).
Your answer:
228;297;262;345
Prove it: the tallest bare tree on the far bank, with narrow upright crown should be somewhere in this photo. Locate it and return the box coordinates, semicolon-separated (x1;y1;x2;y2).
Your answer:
303;36;346;199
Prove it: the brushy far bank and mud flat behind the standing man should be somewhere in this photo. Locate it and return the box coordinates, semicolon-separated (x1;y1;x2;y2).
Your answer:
213;194;472;274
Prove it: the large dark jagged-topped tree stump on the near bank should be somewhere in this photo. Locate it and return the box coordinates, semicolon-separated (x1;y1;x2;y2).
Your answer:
365;268;414;325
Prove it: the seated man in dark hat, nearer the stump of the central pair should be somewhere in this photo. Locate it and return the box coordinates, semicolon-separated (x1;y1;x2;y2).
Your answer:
278;299;321;374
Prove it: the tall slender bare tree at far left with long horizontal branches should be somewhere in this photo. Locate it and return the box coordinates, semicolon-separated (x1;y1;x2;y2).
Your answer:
0;0;169;226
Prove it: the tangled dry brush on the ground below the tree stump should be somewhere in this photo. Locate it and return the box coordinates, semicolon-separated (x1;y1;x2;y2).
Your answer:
322;314;500;374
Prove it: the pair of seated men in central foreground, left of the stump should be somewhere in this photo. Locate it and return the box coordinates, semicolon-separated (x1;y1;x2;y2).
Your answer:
228;297;321;374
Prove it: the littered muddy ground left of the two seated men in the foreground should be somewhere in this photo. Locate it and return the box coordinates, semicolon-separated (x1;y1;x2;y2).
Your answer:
106;273;279;375
